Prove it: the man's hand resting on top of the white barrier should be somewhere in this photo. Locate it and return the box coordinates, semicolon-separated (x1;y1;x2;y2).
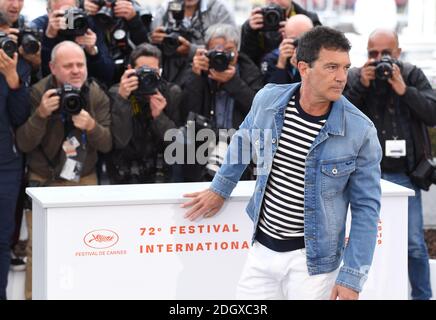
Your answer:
180;189;225;221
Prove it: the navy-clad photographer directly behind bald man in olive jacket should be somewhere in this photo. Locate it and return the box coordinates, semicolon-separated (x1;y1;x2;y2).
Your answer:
31;0;114;86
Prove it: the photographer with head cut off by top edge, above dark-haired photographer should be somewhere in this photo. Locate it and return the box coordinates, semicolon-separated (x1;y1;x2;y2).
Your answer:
83;0;151;83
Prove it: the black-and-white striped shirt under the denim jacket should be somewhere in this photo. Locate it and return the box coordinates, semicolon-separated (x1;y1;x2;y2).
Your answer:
256;92;328;251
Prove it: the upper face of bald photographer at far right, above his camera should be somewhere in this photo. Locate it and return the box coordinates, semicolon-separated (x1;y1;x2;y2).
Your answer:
368;32;401;61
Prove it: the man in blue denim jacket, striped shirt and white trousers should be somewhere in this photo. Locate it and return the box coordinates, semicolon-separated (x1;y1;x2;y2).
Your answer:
183;27;381;299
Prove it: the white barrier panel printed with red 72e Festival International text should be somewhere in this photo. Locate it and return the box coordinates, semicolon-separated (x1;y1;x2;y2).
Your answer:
27;181;411;299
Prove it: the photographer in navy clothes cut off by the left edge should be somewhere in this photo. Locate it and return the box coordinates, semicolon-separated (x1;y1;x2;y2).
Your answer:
0;13;30;300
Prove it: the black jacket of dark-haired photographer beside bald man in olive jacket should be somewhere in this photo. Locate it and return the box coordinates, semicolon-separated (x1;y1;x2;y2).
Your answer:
106;81;182;183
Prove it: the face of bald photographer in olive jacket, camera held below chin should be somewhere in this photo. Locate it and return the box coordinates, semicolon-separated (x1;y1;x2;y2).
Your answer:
50;46;88;88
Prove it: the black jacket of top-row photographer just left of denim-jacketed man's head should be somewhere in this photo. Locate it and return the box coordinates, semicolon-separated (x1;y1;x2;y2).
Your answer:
241;3;321;66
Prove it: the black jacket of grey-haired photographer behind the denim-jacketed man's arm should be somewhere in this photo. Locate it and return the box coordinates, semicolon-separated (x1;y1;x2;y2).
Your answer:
182;53;263;128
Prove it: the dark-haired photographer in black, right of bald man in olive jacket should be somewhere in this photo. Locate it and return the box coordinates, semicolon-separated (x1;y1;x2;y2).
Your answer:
106;44;181;184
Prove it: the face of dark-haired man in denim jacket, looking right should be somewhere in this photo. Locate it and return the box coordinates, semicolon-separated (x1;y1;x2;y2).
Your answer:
298;48;351;102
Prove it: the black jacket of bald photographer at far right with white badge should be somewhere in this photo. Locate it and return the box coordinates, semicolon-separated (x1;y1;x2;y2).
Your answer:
344;62;436;181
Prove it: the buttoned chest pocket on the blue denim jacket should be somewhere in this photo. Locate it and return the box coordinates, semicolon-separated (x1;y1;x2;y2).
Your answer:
321;157;356;195
